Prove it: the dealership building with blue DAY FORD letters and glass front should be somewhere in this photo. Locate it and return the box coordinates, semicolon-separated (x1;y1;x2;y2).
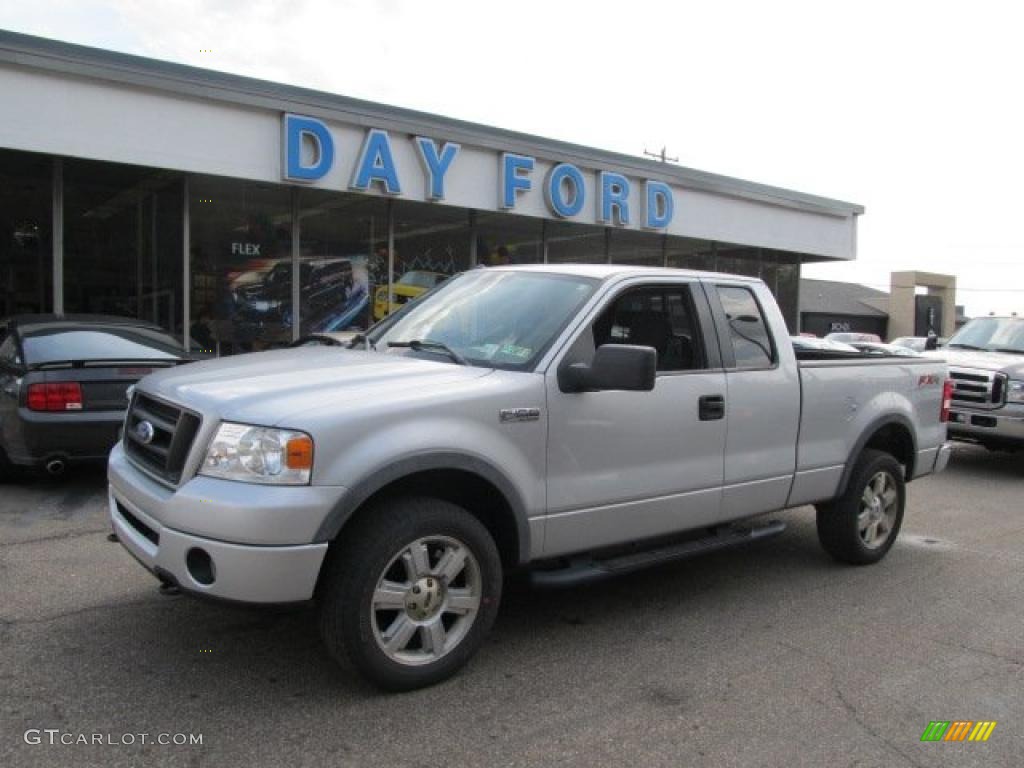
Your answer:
0;32;863;354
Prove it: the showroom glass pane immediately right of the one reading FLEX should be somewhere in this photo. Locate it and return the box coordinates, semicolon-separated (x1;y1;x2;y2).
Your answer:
299;189;388;336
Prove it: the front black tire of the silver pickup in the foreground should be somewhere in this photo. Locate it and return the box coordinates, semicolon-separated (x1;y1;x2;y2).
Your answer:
319;497;502;691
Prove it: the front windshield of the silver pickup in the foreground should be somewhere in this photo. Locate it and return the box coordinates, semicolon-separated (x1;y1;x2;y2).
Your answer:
369;269;598;371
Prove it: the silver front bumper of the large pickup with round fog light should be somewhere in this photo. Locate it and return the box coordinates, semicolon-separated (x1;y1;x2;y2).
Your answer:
108;443;344;603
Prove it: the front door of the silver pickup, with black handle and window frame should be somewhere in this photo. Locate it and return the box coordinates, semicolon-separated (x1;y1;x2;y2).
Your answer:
544;281;726;555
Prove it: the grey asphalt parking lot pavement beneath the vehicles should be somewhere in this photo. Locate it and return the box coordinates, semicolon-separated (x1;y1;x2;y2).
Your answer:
0;447;1024;767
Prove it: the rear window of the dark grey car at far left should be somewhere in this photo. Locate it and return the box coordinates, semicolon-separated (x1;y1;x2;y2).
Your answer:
22;325;183;366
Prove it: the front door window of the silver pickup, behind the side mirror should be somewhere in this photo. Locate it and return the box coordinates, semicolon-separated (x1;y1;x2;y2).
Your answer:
592;285;707;372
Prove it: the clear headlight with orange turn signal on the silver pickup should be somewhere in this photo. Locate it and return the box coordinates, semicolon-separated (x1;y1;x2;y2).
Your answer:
199;421;313;485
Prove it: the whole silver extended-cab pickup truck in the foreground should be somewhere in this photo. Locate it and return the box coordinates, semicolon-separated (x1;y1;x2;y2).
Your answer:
109;265;949;689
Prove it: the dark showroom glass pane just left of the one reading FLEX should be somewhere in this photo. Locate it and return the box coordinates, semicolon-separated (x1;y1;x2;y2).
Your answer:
63;160;182;338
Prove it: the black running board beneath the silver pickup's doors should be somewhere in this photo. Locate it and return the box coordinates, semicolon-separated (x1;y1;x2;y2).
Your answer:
529;520;785;588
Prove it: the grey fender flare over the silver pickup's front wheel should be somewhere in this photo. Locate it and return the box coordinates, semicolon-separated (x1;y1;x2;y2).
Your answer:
313;452;530;563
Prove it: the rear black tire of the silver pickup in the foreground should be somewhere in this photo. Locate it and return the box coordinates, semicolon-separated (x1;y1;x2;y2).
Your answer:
817;449;906;565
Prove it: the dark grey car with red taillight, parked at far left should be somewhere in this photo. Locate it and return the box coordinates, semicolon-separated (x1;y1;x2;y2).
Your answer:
0;314;186;475
